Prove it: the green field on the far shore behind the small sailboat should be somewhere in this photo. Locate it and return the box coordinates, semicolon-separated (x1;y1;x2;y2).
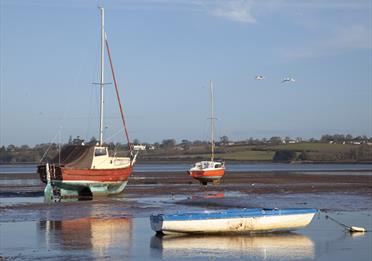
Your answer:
141;142;372;162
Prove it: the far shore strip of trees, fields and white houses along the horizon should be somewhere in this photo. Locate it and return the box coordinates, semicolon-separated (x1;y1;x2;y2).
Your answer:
0;134;372;164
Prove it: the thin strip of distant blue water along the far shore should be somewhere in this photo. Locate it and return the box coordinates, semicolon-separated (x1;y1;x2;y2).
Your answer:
0;162;372;175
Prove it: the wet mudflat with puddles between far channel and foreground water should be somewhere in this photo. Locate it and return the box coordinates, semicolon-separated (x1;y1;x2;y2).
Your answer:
0;172;372;222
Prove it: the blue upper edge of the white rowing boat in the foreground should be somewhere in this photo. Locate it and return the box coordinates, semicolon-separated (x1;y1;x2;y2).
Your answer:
150;208;318;221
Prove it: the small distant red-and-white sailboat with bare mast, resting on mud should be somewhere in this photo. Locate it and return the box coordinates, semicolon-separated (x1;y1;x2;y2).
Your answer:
188;81;225;185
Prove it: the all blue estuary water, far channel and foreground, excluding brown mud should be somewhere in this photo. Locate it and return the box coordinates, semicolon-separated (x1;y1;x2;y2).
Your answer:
0;163;372;261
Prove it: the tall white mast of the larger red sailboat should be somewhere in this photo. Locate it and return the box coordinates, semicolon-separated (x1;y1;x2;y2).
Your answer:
99;7;105;146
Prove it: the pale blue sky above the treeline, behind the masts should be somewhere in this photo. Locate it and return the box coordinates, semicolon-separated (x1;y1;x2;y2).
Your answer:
0;0;372;146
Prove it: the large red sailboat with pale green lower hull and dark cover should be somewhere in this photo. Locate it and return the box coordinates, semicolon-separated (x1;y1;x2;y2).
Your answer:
38;7;136;197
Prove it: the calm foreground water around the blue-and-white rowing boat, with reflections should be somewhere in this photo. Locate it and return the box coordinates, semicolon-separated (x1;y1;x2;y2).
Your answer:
0;211;372;261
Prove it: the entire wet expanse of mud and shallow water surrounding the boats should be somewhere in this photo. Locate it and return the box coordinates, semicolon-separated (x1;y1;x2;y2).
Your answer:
0;171;372;260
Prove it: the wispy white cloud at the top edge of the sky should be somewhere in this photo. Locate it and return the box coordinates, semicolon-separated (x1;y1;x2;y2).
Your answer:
209;0;257;23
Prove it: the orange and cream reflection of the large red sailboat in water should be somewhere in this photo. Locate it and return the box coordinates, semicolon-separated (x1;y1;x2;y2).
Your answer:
39;218;133;257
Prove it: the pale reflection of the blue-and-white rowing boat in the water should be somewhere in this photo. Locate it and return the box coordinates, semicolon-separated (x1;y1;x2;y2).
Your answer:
151;233;315;260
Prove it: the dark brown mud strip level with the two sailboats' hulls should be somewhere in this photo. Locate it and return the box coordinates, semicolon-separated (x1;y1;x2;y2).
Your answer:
0;172;372;197
